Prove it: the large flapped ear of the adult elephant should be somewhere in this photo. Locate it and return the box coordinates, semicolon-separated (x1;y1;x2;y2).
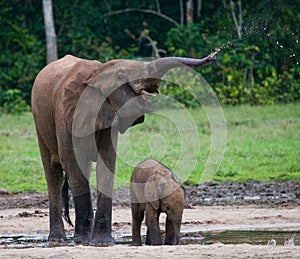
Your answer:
63;61;118;137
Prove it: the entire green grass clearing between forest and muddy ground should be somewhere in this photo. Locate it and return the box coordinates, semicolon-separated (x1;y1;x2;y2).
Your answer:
0;104;300;192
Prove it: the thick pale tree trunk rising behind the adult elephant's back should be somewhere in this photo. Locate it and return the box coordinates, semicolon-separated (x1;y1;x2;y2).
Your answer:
43;0;57;64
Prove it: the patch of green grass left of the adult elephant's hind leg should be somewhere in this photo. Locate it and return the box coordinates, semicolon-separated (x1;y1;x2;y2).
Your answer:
0;113;46;192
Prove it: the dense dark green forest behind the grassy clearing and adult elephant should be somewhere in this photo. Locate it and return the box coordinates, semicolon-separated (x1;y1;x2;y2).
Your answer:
0;0;300;112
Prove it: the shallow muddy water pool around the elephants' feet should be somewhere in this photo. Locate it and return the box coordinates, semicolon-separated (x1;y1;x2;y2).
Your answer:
0;230;300;249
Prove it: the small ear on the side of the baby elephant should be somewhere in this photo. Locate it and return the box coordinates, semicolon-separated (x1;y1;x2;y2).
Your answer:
144;174;160;210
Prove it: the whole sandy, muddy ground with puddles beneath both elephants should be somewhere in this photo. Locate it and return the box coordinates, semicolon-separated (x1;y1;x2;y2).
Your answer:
0;181;300;258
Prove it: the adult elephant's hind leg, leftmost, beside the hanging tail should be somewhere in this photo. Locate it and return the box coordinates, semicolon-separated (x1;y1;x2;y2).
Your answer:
37;133;66;242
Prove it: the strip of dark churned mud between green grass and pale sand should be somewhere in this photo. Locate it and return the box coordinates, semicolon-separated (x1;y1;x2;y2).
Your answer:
0;181;300;209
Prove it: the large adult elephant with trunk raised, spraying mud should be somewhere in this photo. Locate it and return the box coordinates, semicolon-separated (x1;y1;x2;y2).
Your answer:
32;53;216;245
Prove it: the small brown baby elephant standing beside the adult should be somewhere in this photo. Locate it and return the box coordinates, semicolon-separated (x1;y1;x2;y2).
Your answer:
130;159;185;246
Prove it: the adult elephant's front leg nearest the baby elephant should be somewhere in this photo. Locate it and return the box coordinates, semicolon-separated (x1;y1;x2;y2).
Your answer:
92;128;118;246
